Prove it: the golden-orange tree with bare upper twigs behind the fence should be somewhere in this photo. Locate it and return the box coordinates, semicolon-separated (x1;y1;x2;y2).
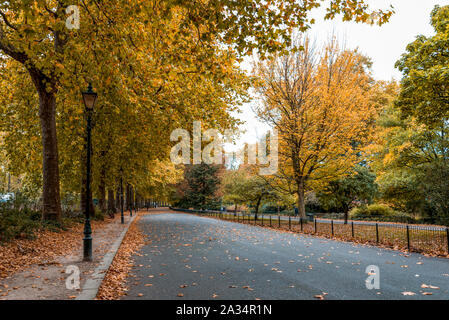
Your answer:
256;38;376;218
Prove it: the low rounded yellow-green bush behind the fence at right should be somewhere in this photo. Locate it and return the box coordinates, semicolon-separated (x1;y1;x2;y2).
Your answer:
349;204;414;223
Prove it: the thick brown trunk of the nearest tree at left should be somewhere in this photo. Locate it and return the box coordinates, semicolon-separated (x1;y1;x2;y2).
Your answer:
34;84;62;221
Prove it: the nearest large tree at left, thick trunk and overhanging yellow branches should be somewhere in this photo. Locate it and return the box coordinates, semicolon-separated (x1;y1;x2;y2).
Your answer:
0;0;392;220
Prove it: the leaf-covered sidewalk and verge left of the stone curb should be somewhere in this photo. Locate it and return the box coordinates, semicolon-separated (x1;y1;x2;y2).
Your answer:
0;212;136;300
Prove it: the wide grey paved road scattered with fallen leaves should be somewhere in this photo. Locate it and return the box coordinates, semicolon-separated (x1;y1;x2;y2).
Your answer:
124;210;449;300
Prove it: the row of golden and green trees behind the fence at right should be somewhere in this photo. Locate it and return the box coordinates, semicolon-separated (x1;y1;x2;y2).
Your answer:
173;6;449;224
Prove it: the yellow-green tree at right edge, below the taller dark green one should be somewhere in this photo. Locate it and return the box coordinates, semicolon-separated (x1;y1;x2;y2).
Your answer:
373;106;449;223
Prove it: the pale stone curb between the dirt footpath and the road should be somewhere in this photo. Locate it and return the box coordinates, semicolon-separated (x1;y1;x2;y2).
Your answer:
75;214;138;300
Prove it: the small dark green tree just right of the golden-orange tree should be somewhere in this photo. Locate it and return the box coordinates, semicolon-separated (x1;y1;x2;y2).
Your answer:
318;165;377;224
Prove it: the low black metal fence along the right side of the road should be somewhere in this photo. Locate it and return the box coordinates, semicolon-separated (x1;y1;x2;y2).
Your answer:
172;208;449;256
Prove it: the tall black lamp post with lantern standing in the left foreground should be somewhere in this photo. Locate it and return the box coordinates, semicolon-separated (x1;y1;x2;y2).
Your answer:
82;83;97;261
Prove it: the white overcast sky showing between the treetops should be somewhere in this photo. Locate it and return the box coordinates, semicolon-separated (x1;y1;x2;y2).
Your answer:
229;0;449;150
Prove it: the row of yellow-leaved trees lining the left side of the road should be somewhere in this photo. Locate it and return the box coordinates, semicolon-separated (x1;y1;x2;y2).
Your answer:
0;0;392;220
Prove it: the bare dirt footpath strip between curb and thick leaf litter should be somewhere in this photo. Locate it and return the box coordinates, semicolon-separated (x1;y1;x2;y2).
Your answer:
0;213;136;300
